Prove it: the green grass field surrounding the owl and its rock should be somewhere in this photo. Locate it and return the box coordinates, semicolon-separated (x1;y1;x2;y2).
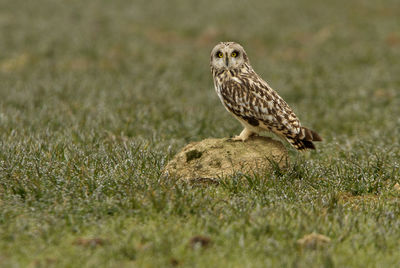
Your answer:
0;0;400;267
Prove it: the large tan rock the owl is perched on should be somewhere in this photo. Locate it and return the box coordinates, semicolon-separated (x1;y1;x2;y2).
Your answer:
164;136;288;180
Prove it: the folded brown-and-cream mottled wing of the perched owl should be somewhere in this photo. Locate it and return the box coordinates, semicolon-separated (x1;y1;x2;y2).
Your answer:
220;76;301;137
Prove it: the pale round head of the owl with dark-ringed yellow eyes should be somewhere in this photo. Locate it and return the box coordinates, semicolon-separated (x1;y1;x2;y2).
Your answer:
210;42;249;70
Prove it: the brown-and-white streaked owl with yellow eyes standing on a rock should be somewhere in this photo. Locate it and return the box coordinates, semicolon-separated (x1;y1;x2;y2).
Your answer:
210;42;322;151
